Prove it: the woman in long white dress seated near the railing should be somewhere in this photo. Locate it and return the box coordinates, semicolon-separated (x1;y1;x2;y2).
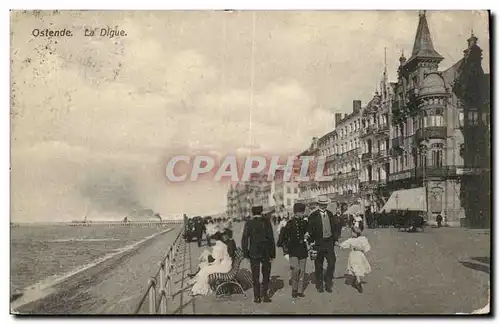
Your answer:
191;232;232;295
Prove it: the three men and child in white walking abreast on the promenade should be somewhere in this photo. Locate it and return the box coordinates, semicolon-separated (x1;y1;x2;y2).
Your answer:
241;196;371;303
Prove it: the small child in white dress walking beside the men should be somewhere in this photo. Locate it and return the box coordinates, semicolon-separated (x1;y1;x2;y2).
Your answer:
339;227;372;293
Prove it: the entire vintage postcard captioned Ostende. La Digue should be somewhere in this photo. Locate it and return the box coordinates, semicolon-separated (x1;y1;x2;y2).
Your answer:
10;10;492;315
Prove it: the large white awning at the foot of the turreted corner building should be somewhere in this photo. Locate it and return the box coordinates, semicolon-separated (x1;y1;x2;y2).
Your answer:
380;187;427;212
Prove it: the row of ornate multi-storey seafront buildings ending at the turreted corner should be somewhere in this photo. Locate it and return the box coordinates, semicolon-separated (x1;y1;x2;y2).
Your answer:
226;11;491;227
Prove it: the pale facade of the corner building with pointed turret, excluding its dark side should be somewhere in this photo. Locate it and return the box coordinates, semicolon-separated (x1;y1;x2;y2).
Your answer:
388;12;489;226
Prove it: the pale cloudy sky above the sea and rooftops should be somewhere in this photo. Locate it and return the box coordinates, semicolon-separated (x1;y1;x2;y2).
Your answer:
11;11;489;222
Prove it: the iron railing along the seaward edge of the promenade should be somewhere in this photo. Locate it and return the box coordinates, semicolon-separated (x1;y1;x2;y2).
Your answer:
135;226;190;314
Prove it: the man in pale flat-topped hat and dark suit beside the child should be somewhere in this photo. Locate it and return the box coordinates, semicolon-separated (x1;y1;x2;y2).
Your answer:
306;196;342;293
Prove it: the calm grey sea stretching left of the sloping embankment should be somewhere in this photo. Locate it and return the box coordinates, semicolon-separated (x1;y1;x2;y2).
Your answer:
10;225;172;291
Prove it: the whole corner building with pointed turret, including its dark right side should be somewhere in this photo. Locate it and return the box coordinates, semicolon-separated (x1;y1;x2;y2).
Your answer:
386;12;491;227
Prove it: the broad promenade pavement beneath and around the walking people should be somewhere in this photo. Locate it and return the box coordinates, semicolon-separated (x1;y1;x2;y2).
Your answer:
191;223;490;315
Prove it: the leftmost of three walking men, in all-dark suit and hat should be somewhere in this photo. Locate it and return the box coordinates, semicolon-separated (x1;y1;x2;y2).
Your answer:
241;206;276;303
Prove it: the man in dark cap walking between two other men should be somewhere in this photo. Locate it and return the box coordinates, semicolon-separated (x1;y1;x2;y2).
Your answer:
277;203;308;298
